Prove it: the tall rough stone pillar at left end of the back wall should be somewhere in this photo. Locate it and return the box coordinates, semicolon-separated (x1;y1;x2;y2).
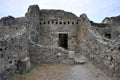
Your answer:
25;5;40;43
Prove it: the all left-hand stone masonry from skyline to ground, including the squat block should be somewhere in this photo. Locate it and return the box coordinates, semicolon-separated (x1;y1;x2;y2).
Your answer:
0;13;30;80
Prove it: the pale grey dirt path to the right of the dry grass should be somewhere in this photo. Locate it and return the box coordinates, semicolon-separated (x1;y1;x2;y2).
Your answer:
62;62;111;80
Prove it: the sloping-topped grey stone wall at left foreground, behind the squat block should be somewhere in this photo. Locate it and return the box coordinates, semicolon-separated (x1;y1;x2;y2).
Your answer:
0;26;30;80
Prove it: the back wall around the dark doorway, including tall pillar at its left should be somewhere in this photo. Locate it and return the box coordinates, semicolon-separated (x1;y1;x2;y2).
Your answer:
26;5;80;50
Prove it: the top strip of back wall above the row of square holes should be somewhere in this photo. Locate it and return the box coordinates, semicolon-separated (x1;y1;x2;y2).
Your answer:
40;10;78;20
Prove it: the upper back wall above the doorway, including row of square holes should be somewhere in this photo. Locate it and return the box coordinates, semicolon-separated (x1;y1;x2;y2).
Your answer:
39;10;80;32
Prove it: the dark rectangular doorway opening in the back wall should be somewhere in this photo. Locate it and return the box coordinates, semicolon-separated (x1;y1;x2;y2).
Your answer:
59;34;68;49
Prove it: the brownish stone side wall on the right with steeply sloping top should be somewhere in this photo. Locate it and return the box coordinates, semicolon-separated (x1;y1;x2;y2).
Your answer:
79;15;120;80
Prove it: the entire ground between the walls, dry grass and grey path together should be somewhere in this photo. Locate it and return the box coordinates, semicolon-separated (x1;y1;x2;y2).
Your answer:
8;63;112;80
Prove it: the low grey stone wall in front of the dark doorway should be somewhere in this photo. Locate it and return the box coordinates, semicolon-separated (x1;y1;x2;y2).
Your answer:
29;43;68;64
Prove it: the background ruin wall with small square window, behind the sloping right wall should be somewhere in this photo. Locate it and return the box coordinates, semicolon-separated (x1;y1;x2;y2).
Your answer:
90;22;120;40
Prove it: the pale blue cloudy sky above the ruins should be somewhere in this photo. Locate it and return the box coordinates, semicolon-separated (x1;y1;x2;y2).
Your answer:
0;0;120;23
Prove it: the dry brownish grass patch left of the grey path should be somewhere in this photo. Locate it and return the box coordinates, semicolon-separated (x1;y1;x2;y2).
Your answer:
8;64;68;80
